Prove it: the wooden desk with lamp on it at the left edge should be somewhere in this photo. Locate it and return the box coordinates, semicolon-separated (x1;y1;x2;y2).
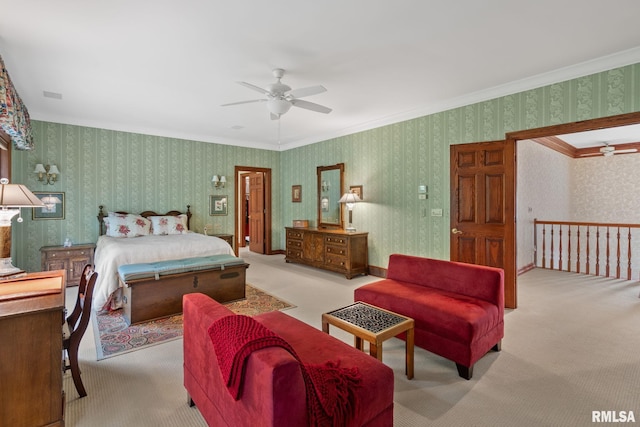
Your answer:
0;271;65;427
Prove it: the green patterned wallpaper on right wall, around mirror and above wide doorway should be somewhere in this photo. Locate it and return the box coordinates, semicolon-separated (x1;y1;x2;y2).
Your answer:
281;64;640;267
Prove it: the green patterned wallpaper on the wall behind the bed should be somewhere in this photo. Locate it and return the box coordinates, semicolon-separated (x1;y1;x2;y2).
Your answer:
12;126;282;271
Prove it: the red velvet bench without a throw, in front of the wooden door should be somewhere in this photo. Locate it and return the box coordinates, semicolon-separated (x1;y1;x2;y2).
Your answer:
354;254;504;379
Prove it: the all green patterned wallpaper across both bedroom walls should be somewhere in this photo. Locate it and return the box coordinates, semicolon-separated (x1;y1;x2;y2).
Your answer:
12;64;640;270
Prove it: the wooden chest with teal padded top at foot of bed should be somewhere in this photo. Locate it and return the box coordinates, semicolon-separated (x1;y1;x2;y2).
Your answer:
118;256;249;324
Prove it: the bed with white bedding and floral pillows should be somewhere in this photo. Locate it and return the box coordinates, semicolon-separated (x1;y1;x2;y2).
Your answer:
93;206;247;320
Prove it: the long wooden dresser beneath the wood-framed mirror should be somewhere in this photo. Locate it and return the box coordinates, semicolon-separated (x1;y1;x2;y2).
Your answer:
285;227;369;279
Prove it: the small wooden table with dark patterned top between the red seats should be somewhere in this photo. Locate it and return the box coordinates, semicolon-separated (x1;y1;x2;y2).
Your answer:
322;302;414;379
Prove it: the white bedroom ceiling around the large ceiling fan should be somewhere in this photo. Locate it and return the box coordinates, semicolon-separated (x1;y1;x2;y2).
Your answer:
0;0;640;150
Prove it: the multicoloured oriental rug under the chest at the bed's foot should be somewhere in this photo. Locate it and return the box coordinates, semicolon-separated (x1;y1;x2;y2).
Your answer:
92;285;295;360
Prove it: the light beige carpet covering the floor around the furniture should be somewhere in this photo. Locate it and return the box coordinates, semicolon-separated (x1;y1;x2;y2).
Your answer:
64;252;640;427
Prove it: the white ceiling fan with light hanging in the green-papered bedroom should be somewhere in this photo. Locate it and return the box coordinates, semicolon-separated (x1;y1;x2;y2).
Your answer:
222;68;331;120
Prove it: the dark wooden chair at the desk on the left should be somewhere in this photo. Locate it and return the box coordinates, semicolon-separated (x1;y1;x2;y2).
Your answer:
62;264;98;397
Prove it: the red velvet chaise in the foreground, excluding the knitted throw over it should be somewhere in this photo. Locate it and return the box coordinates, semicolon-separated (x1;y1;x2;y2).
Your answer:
183;293;394;427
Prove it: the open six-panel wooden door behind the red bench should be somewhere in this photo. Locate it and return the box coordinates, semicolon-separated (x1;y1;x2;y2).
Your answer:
450;141;517;308
